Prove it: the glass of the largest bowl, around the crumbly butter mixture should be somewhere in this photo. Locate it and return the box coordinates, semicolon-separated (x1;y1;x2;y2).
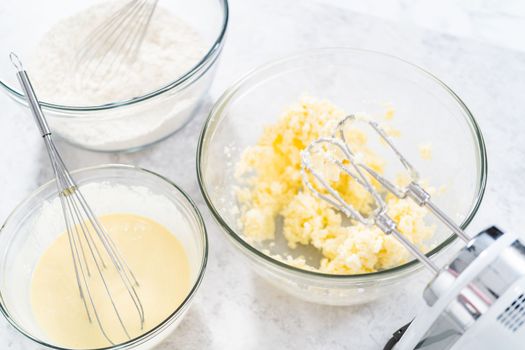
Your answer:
197;48;487;305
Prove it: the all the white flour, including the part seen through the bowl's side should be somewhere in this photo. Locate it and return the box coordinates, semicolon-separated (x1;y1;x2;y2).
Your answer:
28;1;207;151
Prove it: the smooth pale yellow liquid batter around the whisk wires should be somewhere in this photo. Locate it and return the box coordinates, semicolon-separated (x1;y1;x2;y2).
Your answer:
31;214;190;348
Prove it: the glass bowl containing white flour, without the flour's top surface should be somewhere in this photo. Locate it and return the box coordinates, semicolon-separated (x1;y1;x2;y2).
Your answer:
0;0;228;151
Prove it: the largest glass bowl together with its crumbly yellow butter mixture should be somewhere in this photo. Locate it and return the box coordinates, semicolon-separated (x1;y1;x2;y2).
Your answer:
197;48;486;305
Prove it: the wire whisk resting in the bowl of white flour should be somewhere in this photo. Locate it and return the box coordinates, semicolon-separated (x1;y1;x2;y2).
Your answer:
76;0;158;76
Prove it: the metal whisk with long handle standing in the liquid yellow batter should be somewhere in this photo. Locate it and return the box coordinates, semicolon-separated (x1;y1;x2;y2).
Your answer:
10;53;144;344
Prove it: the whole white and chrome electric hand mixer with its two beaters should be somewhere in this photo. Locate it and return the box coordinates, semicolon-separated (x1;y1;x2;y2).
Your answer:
301;115;525;350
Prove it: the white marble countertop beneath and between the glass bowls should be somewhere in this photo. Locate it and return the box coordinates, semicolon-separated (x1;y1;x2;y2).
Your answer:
0;0;525;350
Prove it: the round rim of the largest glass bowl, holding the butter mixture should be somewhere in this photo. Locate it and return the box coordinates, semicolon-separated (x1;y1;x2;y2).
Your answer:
196;47;488;282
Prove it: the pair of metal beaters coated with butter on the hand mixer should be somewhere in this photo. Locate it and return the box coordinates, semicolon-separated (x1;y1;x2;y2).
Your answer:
301;115;470;273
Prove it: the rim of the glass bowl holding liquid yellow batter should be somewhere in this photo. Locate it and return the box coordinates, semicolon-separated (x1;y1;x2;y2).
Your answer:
0;164;209;350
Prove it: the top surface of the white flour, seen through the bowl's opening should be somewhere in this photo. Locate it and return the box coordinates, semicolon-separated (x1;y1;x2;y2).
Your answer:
30;1;206;106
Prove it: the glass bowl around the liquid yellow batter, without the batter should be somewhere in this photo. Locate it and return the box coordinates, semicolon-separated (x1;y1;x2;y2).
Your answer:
0;165;208;350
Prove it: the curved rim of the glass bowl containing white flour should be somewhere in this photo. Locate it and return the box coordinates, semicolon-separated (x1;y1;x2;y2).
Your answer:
0;0;229;113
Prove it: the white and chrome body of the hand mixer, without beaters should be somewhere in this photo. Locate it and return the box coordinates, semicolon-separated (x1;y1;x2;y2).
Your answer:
385;227;525;350
